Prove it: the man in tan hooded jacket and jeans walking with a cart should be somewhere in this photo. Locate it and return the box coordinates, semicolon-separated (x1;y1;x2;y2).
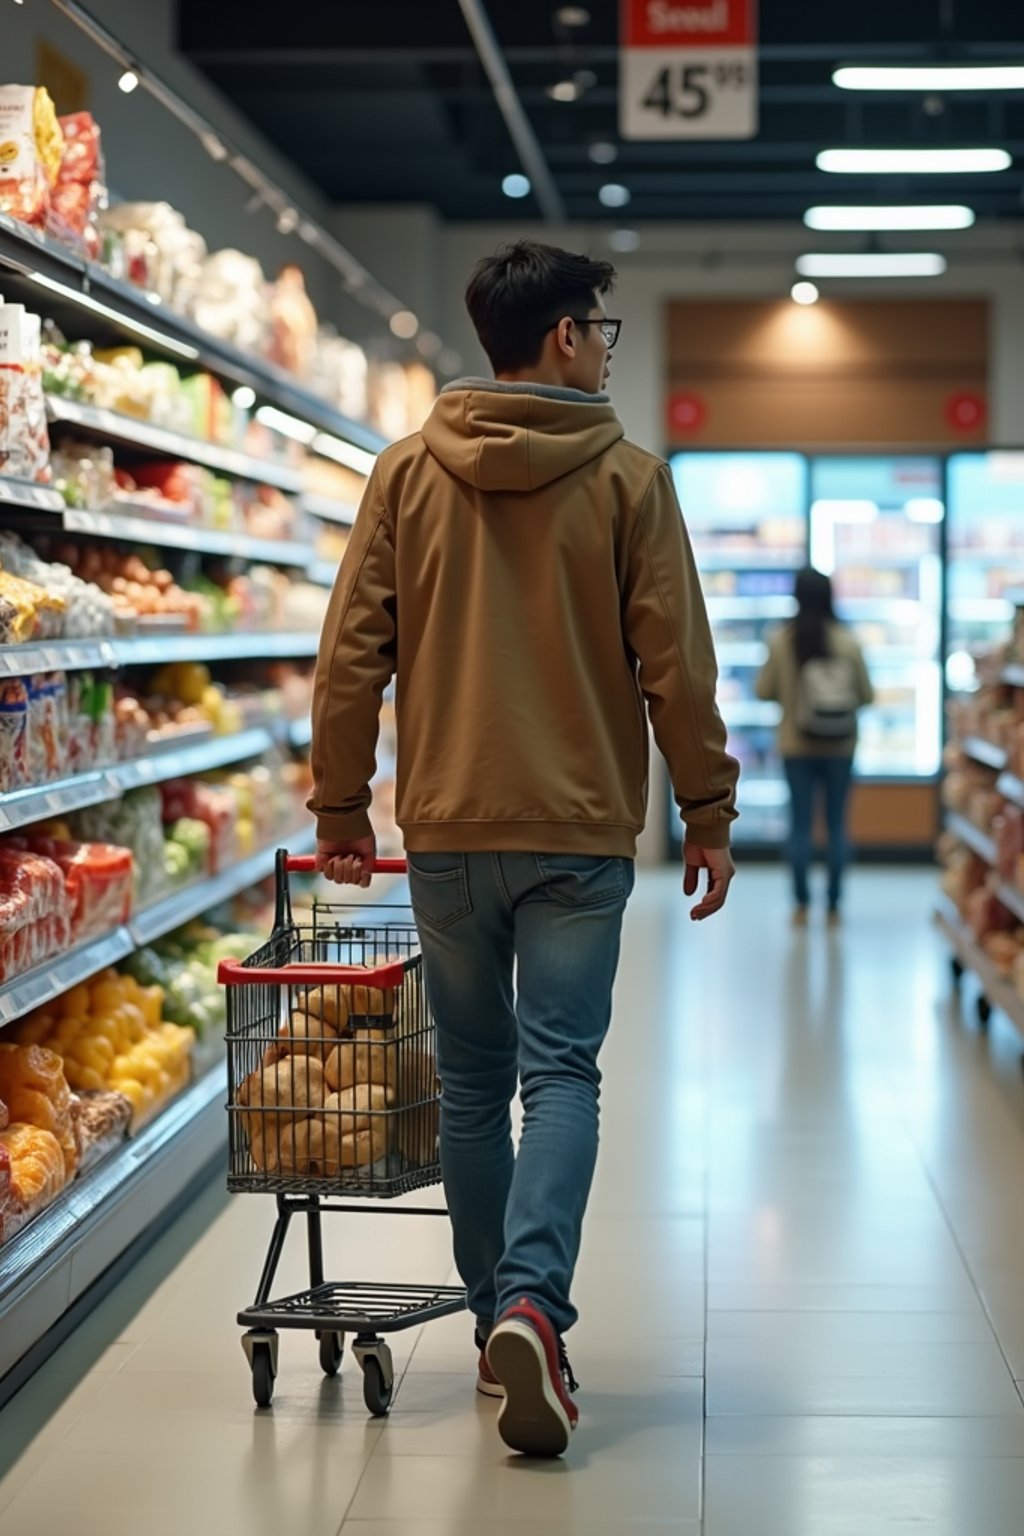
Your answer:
310;240;738;1455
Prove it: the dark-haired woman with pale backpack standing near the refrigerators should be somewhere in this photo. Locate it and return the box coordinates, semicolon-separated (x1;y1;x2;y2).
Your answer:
757;570;875;928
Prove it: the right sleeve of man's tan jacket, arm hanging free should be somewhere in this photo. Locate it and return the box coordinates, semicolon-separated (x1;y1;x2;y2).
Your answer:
623;465;740;848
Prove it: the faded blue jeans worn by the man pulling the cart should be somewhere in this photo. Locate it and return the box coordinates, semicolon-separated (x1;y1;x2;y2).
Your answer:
408;852;634;1333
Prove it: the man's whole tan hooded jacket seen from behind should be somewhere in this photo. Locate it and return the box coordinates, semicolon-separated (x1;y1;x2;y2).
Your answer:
310;379;738;857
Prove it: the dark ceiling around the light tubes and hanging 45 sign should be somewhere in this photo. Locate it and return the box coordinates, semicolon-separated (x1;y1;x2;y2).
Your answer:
178;0;1024;224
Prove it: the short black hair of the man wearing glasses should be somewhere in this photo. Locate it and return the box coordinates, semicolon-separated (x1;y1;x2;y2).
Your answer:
465;240;616;373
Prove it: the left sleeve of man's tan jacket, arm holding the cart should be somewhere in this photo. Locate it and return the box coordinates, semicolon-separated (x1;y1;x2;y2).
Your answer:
309;465;398;842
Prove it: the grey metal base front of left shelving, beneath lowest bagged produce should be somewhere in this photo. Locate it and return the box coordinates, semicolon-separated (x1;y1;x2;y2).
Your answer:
0;1061;227;1404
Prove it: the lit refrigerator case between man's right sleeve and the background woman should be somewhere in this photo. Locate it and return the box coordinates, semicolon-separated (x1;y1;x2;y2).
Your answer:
669;453;808;846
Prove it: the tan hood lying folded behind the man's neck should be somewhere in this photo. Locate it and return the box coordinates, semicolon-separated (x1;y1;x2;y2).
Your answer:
424;379;623;492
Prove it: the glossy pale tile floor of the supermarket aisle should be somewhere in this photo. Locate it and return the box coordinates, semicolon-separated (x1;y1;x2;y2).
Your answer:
0;868;1024;1536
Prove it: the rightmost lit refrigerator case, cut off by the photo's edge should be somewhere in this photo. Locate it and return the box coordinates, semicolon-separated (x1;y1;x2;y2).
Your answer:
946;450;1024;693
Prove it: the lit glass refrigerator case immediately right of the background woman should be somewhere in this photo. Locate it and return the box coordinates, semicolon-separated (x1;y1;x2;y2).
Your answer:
811;455;946;779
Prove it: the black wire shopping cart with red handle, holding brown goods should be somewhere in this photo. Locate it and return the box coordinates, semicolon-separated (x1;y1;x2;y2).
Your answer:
218;849;465;1416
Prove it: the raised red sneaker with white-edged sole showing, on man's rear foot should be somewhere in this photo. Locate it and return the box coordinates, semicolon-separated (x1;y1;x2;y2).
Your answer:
487;1296;579;1456
